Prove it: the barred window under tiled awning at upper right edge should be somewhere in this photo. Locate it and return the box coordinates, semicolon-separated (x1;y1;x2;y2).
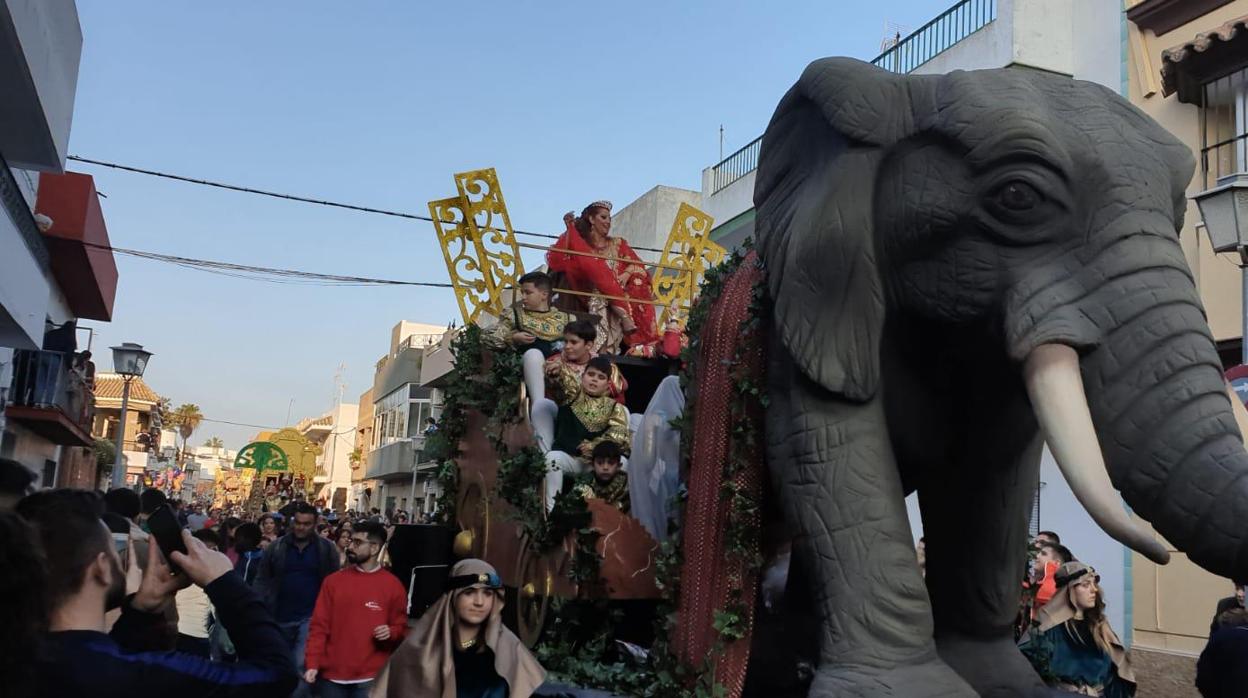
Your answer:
1201;69;1248;190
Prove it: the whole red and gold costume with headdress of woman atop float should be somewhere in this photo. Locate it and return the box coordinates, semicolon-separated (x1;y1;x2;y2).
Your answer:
547;201;658;353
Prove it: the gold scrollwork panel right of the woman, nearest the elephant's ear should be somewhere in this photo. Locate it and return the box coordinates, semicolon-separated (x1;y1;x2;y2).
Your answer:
653;202;728;328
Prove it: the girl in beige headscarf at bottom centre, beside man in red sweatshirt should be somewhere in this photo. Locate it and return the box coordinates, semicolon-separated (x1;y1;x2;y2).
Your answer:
372;559;545;698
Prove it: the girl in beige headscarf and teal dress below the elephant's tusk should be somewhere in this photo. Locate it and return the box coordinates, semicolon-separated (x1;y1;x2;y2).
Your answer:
1018;562;1136;698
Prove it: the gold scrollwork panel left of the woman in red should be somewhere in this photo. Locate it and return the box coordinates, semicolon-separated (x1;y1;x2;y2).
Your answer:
429;167;524;323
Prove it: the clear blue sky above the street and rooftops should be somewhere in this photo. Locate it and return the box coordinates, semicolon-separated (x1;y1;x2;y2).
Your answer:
70;0;952;448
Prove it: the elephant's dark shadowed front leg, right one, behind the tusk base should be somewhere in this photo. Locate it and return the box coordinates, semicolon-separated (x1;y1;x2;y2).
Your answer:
919;405;1050;697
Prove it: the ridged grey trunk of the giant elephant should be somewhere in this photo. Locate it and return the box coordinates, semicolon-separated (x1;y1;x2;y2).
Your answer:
1055;297;1248;578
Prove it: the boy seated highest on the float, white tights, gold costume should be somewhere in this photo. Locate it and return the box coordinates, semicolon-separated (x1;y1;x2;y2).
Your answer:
489;271;574;414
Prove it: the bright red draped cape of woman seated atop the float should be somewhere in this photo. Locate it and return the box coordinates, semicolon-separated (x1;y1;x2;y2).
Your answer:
547;225;659;345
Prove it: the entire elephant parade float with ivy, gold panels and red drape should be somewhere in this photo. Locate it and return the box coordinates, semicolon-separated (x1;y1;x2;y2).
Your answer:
404;59;1248;697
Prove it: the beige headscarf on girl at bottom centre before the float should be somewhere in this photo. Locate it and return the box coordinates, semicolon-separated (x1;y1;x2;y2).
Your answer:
371;559;545;698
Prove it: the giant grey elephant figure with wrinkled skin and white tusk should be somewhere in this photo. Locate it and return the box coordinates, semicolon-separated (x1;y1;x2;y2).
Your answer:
754;59;1248;697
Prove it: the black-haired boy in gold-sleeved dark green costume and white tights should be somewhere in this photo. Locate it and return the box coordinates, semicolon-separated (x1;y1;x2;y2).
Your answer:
533;356;631;511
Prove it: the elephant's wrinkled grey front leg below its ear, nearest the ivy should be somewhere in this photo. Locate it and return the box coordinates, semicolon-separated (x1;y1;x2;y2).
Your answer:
768;362;975;697
